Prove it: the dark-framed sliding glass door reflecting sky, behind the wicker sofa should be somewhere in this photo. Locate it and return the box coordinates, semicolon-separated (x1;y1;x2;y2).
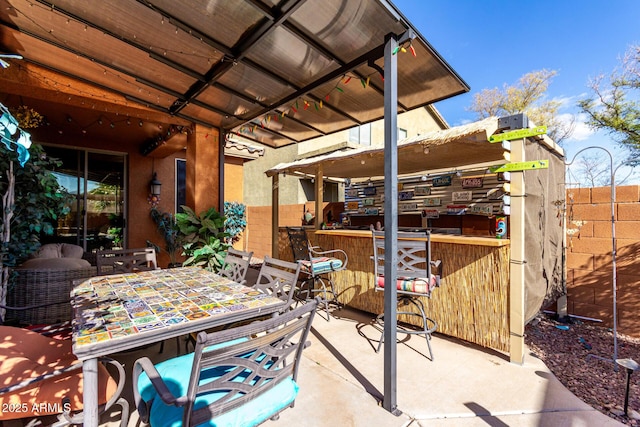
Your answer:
45;146;126;252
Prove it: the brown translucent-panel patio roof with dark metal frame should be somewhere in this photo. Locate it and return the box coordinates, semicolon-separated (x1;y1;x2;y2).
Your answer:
0;0;469;147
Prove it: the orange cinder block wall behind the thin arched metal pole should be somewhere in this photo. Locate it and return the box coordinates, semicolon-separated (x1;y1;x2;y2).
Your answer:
567;185;640;337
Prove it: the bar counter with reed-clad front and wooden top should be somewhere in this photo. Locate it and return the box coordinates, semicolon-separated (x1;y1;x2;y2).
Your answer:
285;229;510;352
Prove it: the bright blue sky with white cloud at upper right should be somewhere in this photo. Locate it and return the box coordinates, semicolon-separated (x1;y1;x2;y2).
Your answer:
392;0;640;184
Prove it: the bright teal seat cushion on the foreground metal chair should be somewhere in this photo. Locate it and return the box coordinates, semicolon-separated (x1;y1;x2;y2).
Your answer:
138;340;298;427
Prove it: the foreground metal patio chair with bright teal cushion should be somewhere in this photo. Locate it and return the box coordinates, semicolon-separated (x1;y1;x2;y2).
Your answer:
133;301;318;427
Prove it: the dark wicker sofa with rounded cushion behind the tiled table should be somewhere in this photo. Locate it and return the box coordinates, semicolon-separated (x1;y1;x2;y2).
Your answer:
6;243;96;325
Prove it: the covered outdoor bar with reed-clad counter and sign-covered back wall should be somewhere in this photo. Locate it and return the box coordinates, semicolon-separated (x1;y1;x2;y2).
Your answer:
266;118;566;364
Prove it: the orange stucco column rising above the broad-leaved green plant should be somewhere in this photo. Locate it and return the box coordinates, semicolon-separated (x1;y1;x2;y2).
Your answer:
187;124;223;214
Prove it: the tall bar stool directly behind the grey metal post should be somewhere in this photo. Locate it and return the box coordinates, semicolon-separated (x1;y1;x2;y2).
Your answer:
371;227;442;360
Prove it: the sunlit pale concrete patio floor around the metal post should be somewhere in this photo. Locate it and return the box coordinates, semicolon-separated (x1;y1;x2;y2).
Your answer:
101;309;623;427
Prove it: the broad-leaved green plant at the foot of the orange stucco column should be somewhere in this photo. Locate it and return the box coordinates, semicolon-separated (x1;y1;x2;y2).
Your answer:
175;206;229;271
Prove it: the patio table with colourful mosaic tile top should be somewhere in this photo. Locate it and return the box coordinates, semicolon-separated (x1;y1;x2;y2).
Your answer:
71;267;285;426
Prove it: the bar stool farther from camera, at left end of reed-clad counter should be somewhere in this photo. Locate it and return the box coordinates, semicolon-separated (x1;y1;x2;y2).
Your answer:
287;227;348;320
